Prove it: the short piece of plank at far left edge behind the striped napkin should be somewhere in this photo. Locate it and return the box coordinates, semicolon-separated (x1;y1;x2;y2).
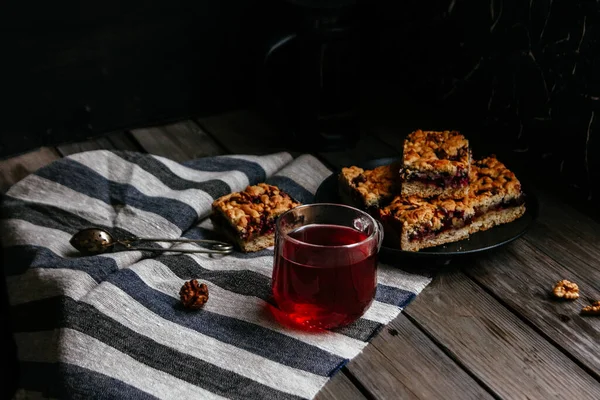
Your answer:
0;147;60;192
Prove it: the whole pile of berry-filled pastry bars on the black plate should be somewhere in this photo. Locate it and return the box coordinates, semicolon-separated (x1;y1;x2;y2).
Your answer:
339;131;525;251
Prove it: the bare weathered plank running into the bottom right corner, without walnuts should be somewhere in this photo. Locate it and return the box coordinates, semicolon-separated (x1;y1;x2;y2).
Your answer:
404;271;600;400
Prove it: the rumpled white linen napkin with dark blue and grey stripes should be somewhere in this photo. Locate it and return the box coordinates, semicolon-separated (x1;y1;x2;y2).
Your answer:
1;150;430;399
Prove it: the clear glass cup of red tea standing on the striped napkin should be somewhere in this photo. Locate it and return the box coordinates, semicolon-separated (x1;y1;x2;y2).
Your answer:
272;203;383;329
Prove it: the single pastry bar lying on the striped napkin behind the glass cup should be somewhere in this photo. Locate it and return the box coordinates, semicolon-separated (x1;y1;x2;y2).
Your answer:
210;183;300;252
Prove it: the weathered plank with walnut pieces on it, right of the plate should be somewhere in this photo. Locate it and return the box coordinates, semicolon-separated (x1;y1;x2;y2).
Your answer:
465;240;600;380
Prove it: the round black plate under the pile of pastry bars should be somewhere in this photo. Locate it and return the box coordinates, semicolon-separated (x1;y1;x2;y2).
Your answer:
315;158;539;257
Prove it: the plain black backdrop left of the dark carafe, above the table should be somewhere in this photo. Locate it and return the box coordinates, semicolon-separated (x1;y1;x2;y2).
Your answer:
0;0;272;156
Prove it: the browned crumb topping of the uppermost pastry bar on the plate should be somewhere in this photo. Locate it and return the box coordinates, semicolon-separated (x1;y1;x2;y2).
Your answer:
404;129;471;175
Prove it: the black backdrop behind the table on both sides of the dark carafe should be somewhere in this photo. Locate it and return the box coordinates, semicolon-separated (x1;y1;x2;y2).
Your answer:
0;0;600;201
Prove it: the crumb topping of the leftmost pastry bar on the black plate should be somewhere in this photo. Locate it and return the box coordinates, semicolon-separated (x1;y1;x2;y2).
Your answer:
342;165;397;205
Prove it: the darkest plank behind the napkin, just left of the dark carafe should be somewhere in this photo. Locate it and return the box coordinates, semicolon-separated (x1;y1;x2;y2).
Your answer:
197;110;288;154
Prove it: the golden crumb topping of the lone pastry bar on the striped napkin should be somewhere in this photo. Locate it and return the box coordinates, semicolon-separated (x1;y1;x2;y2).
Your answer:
212;183;300;237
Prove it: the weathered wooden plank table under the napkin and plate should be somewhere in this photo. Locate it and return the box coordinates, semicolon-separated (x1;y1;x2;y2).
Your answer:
0;111;600;400
